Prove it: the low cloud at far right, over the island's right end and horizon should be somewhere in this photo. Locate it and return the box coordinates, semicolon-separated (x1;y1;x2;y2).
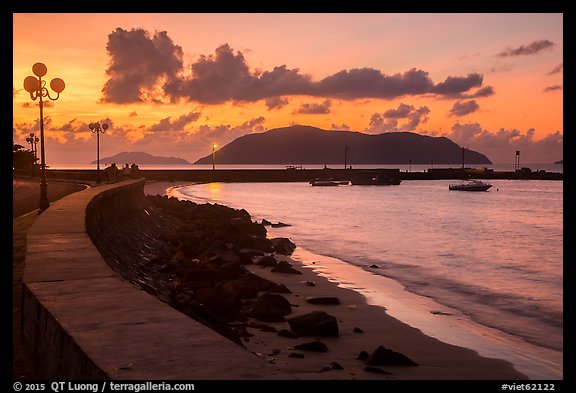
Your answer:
444;122;564;164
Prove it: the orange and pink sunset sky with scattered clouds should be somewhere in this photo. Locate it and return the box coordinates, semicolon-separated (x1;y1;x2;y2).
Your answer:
13;13;564;166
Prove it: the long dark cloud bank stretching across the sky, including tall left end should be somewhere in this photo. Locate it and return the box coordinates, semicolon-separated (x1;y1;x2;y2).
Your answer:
102;28;496;104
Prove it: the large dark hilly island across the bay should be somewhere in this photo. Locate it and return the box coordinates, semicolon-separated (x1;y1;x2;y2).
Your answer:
195;125;492;165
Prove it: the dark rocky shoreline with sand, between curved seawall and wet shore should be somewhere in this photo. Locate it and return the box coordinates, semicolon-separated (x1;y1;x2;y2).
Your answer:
93;191;525;379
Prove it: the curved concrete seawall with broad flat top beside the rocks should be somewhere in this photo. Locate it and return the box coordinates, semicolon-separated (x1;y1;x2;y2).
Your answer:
22;179;291;380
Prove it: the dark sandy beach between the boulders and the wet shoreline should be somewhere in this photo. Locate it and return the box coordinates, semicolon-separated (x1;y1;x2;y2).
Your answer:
145;182;528;380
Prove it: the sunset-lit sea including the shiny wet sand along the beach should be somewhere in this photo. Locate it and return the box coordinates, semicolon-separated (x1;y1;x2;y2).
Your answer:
148;167;564;380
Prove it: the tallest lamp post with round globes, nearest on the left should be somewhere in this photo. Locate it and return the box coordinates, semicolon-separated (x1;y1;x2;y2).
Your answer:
24;63;66;213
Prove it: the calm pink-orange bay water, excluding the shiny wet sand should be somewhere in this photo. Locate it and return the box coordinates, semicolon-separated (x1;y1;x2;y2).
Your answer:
165;180;563;374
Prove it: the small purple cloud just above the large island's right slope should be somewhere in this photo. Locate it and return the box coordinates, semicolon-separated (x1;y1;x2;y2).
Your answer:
364;103;430;133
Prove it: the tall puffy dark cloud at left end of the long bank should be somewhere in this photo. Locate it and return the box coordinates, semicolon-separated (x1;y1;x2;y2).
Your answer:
102;28;183;104
